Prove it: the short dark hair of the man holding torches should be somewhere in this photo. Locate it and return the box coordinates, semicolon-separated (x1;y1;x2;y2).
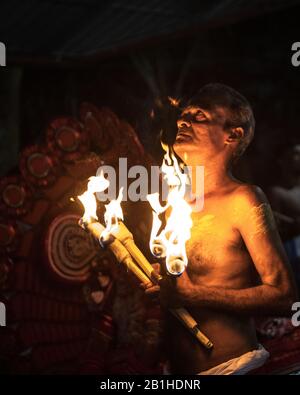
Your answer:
188;83;255;156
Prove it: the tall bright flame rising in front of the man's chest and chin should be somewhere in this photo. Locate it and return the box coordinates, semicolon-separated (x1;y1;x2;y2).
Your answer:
147;147;193;275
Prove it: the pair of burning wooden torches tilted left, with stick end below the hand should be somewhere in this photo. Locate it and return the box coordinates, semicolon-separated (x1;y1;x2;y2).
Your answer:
78;174;213;348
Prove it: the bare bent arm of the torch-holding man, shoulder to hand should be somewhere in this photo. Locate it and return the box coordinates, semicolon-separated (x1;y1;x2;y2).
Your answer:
177;187;297;315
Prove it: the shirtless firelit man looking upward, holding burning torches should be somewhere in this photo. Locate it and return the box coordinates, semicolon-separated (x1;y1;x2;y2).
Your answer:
146;84;297;374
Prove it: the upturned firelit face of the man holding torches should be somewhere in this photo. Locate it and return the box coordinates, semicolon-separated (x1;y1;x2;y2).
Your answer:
174;106;228;159
